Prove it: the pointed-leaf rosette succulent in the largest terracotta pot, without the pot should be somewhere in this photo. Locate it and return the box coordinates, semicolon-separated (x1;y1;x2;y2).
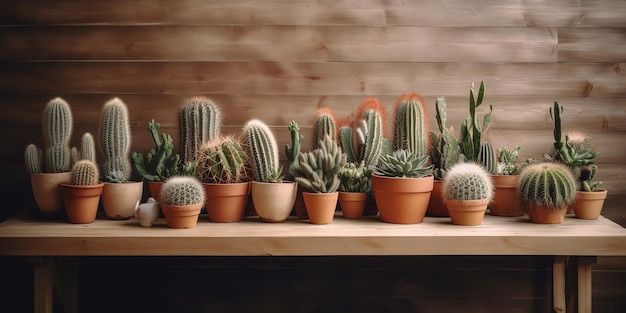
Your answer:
374;149;433;178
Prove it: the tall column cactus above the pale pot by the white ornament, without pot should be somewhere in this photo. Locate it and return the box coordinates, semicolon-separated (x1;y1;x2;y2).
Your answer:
100;98;132;183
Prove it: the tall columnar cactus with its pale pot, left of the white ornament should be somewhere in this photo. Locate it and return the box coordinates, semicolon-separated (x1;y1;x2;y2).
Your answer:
100;98;143;220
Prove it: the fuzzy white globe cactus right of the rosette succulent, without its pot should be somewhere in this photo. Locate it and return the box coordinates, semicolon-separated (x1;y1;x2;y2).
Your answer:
443;162;494;200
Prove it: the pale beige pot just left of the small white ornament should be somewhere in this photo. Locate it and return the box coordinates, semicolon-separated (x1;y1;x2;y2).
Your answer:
102;181;143;220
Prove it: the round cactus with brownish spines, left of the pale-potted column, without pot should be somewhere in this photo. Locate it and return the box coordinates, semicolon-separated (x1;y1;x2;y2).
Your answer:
196;136;248;184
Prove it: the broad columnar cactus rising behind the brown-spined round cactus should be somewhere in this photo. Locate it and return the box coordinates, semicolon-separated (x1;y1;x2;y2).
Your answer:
178;97;222;162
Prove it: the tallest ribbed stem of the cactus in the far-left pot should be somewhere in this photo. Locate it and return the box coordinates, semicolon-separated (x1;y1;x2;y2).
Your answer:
43;98;73;173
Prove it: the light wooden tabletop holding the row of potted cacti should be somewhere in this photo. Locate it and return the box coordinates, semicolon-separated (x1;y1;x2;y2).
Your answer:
0;214;626;256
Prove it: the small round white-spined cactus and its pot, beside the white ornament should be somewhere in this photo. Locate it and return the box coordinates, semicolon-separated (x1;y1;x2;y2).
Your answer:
161;176;205;228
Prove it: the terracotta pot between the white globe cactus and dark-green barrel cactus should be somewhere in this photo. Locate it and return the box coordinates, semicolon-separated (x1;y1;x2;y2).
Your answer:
489;175;524;216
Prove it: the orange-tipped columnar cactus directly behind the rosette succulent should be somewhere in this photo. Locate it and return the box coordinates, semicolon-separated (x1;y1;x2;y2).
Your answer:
393;93;430;156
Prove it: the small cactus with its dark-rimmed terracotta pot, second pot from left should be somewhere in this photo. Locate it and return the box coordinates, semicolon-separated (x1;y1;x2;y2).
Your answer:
59;160;104;224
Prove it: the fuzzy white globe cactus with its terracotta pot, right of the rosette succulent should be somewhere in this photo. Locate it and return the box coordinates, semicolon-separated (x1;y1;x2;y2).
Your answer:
443;162;493;226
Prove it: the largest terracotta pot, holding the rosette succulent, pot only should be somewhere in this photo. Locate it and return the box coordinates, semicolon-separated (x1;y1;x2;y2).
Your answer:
372;175;434;224
